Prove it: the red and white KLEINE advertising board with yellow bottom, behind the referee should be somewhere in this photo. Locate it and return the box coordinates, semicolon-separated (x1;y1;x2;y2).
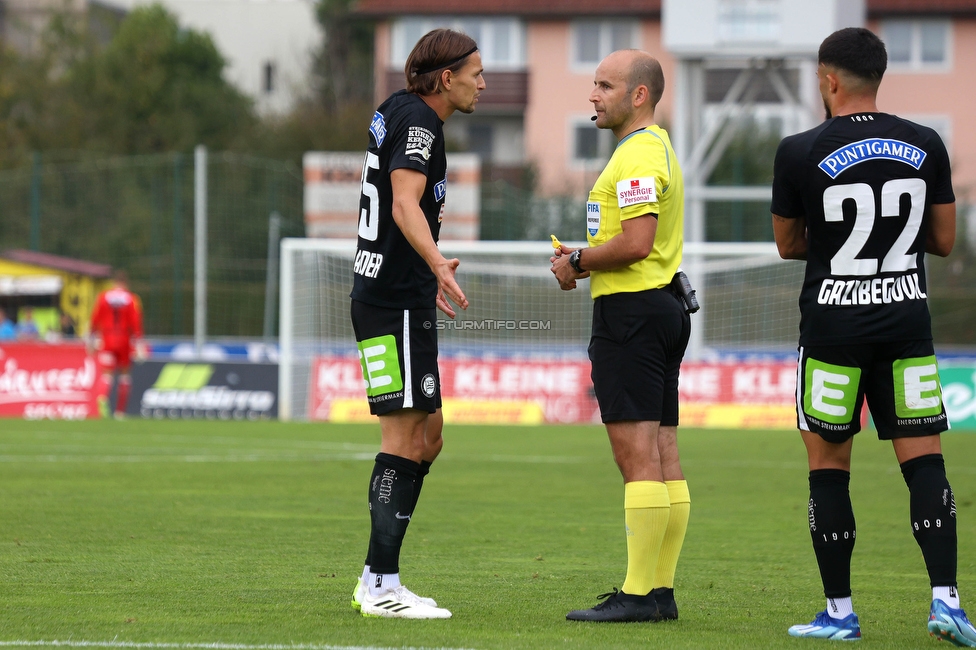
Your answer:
308;355;796;429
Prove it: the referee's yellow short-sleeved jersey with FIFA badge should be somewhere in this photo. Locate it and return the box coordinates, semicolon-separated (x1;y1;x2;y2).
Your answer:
586;124;685;298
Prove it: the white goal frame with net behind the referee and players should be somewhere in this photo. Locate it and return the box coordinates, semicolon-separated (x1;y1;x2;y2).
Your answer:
279;239;803;420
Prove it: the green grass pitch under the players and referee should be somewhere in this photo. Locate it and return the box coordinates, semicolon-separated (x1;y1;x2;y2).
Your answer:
0;420;976;649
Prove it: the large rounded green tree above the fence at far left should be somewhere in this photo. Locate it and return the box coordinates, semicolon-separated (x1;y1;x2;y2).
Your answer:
0;5;257;166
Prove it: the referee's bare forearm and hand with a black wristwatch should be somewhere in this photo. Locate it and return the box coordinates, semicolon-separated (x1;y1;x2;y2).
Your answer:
551;213;657;290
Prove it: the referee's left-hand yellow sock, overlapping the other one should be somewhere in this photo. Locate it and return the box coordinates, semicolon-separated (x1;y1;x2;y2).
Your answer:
623;481;670;596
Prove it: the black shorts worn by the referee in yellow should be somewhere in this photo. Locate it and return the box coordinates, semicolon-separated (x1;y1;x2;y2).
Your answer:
588;287;691;426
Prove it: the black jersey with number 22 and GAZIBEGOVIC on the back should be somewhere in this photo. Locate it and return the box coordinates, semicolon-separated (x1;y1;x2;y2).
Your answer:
772;113;955;346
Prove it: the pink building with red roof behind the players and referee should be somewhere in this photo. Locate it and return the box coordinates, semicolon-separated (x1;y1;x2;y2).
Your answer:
356;0;976;215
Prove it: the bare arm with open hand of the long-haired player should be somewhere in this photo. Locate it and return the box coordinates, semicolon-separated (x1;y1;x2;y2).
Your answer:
390;169;468;310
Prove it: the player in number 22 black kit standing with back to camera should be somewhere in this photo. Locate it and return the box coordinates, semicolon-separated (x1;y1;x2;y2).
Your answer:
772;27;976;647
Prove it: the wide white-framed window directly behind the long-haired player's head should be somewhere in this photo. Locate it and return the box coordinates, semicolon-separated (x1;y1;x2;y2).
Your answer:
390;16;525;71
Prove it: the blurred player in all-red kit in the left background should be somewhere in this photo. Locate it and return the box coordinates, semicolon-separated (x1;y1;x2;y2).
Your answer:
90;271;146;418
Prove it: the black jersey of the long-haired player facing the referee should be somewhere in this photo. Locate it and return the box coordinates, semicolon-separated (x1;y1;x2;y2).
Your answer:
350;90;447;309
